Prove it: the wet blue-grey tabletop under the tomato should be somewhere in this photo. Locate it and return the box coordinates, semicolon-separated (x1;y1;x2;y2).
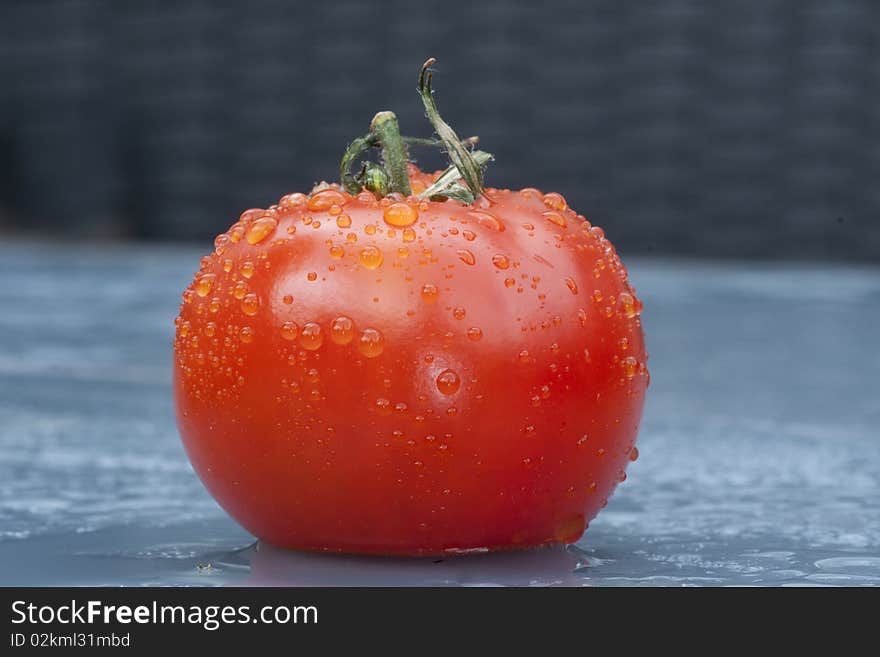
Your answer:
0;243;880;586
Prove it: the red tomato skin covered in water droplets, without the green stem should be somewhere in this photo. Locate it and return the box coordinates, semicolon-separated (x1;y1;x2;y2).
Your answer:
174;174;648;555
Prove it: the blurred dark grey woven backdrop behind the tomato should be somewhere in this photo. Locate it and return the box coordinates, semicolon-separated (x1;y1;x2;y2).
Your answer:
0;0;880;261
